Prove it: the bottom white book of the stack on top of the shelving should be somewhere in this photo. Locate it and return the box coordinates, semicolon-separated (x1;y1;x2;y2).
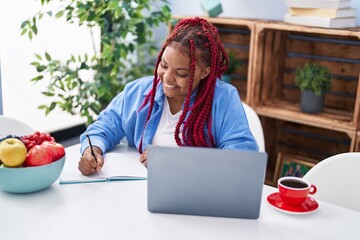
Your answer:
284;13;356;28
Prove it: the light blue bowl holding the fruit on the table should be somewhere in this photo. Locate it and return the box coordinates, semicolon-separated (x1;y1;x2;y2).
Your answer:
0;156;65;193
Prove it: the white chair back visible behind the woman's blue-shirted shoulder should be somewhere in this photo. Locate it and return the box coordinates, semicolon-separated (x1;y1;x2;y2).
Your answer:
243;103;265;152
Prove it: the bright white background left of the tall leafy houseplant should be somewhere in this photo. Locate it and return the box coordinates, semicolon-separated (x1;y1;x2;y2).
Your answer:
0;0;98;131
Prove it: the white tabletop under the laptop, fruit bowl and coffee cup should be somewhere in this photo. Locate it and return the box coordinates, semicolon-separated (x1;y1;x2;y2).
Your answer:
0;143;360;240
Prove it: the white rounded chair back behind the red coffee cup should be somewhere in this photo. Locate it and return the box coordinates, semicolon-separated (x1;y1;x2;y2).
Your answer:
304;152;360;212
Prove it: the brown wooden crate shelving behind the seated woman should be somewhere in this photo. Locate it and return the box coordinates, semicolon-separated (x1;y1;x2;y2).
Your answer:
172;17;360;185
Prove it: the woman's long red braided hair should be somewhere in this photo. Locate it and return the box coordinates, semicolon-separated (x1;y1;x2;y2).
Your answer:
139;17;229;153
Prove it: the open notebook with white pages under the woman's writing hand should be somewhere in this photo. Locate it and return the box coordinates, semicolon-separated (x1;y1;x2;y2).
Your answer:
59;145;147;184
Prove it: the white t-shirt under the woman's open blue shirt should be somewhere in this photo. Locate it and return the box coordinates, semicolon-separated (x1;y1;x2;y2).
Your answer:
152;97;182;147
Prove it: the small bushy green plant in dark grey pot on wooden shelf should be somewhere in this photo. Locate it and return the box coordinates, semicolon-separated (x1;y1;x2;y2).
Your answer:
295;63;331;113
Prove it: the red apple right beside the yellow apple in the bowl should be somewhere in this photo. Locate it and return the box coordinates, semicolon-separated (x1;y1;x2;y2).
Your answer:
25;145;52;167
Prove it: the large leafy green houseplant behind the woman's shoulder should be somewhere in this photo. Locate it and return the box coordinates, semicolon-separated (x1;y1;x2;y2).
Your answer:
21;0;171;124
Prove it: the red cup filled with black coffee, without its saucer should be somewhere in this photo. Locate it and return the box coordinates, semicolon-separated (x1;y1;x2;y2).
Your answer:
278;177;317;205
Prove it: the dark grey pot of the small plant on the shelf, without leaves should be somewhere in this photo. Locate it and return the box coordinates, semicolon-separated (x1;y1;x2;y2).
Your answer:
300;90;325;113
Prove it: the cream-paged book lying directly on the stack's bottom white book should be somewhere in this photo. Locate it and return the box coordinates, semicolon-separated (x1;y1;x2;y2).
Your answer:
289;8;356;18
